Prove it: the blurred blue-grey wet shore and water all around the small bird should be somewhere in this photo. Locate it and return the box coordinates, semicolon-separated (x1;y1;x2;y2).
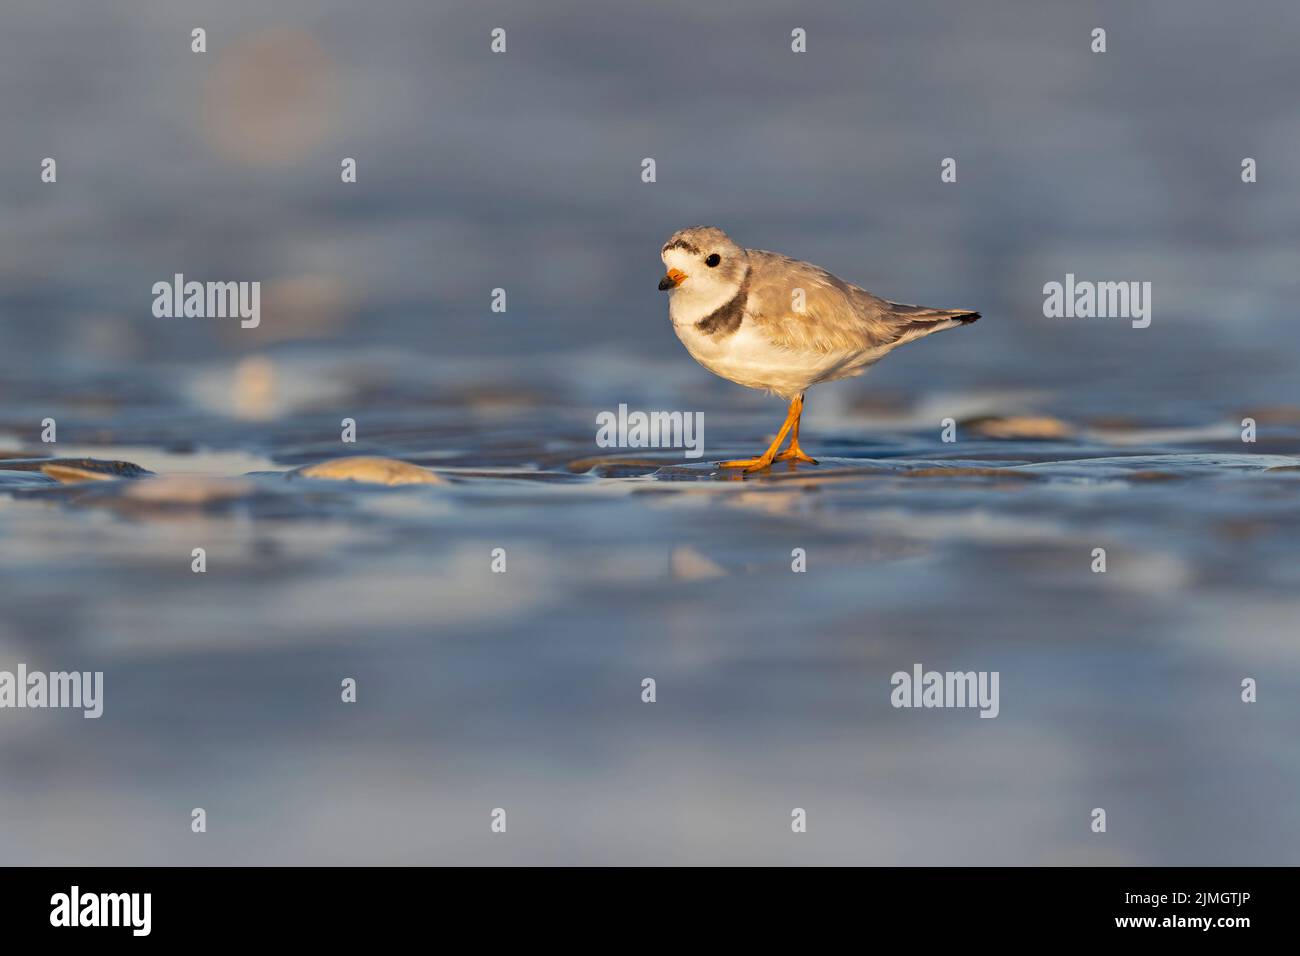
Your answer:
0;0;1300;864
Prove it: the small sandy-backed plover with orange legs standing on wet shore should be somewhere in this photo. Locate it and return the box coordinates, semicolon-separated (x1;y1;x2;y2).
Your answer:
659;226;979;471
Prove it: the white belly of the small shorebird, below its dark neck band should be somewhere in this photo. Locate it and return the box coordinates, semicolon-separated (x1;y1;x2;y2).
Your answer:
672;306;884;399
